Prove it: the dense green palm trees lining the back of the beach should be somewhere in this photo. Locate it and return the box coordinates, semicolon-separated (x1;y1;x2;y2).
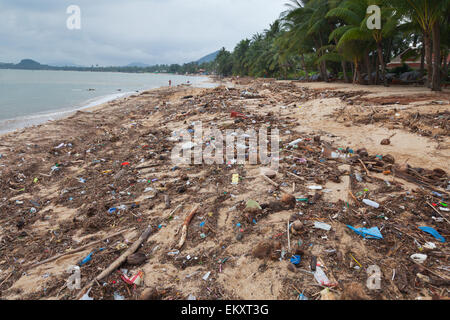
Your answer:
213;0;450;91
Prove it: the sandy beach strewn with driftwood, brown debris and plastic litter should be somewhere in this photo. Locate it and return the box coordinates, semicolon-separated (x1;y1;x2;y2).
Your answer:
0;78;450;300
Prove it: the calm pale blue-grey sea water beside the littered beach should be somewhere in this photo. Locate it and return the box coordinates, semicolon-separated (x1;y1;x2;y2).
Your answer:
0;69;214;134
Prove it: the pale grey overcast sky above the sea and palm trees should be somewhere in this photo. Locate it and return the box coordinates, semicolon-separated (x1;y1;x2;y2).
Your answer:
0;0;288;66
